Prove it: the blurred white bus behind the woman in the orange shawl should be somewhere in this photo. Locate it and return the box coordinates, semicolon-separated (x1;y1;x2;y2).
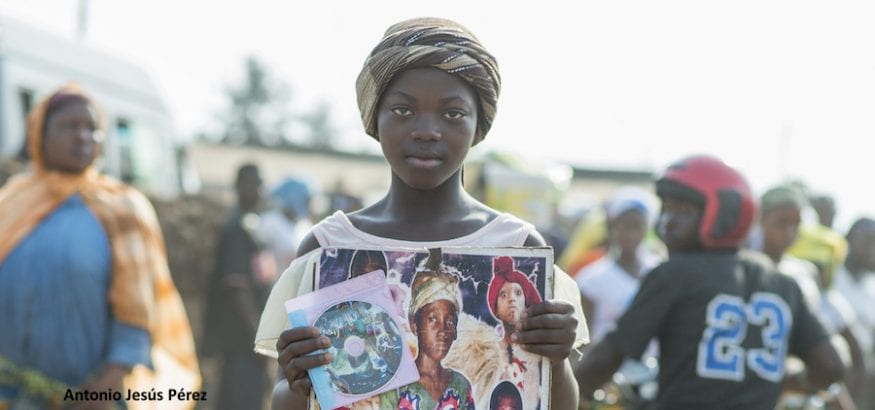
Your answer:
0;16;196;197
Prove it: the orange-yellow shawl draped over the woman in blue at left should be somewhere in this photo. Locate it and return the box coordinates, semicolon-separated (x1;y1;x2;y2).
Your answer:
0;85;200;408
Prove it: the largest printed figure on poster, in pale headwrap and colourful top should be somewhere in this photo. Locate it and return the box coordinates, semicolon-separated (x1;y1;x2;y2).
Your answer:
381;249;474;410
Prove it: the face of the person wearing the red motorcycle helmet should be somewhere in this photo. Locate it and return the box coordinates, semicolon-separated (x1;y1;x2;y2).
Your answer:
657;197;702;252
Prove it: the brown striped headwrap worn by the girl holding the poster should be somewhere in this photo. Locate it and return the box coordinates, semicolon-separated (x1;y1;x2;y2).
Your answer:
356;18;501;143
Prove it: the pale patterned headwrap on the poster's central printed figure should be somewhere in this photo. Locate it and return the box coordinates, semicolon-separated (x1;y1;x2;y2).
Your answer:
407;249;462;324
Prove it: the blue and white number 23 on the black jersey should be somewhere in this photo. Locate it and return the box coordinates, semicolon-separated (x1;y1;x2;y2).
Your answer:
696;293;793;382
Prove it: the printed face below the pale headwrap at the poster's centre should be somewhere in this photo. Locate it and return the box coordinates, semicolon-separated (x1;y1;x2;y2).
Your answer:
413;300;458;362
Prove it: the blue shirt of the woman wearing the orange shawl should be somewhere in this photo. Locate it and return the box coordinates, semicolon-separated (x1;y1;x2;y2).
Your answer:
0;195;151;386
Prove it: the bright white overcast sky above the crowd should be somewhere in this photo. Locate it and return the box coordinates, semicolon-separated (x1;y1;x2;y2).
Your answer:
0;0;875;228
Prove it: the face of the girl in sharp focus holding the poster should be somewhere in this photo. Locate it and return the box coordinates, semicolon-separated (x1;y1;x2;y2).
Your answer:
377;68;478;189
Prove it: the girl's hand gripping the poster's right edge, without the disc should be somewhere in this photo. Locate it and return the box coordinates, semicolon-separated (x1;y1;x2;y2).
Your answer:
511;300;577;365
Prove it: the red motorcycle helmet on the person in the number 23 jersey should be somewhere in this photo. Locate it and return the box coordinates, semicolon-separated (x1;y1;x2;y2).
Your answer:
656;155;757;249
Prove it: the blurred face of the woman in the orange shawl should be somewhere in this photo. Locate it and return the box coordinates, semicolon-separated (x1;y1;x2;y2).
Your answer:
42;99;103;174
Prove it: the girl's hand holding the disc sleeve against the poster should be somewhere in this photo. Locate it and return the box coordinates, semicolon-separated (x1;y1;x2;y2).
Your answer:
276;327;333;397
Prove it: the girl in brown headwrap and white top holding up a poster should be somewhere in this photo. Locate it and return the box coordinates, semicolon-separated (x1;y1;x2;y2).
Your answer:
256;18;588;409
